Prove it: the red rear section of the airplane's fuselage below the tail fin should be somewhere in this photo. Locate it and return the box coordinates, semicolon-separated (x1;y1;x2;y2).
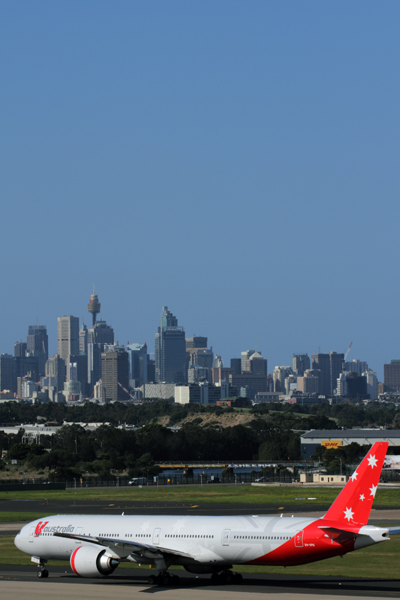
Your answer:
245;519;362;567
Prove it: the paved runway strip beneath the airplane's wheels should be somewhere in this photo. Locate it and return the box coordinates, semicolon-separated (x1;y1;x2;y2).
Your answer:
0;565;400;600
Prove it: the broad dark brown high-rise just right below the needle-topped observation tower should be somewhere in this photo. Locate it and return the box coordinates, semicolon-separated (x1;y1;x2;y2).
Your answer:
101;346;129;401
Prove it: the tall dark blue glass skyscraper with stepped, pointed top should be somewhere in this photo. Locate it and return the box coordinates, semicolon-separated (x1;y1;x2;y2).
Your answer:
155;306;187;383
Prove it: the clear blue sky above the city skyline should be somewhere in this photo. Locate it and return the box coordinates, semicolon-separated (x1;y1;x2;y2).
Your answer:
0;0;400;378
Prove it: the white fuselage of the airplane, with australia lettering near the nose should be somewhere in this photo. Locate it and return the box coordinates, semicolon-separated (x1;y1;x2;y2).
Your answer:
15;515;313;564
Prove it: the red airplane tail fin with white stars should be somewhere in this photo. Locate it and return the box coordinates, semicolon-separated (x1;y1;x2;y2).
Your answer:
325;442;389;525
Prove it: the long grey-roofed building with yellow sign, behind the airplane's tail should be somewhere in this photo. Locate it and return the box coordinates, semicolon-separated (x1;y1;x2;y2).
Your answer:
300;429;400;459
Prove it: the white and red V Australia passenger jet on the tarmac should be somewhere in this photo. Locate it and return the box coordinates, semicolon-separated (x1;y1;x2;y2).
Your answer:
15;442;400;586
